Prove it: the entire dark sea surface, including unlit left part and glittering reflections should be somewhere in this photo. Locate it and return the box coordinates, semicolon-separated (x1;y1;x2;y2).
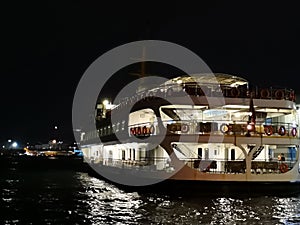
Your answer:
0;158;300;225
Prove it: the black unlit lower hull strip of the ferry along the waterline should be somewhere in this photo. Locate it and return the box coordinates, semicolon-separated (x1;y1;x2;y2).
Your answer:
89;163;300;197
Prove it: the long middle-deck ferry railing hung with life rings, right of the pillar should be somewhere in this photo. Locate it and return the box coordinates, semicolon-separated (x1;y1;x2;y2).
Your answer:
163;120;299;137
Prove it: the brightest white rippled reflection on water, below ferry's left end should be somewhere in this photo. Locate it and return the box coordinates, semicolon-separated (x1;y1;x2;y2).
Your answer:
78;174;142;224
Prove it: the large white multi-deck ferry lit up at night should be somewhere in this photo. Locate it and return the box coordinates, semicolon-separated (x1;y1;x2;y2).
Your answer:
81;73;300;195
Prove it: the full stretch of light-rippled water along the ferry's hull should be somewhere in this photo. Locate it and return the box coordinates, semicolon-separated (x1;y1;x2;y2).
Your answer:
75;172;300;224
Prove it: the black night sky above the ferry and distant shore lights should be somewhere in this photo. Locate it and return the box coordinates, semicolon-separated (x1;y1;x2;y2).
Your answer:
0;1;300;142
